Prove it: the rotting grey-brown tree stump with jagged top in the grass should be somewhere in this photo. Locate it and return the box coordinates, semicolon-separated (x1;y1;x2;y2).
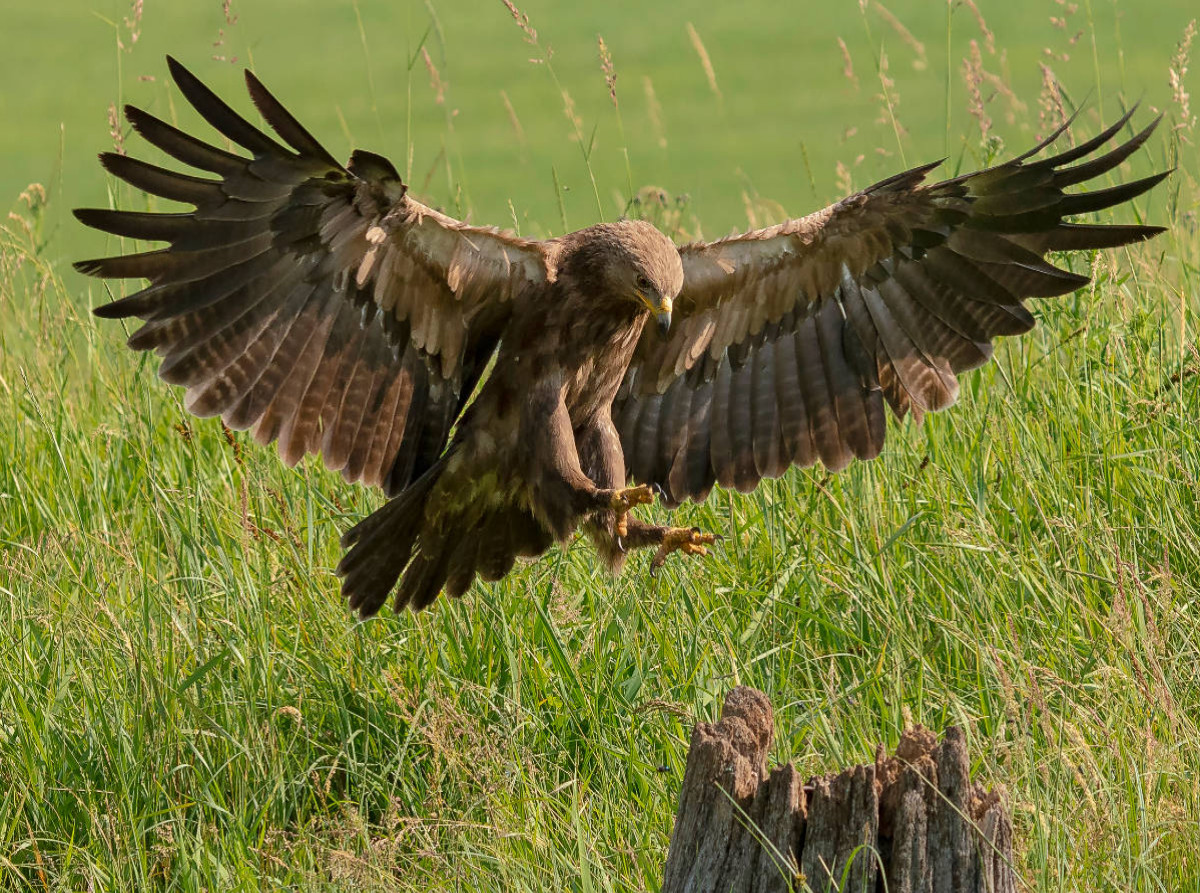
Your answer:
662;685;1016;893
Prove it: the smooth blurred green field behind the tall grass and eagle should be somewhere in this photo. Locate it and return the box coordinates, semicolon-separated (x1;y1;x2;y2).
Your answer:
0;0;1195;250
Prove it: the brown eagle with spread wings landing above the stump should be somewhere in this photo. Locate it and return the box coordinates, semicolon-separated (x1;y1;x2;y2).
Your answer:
76;58;1165;617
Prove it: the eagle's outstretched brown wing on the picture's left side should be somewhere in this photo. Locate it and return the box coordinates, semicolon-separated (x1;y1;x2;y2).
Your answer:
76;58;546;495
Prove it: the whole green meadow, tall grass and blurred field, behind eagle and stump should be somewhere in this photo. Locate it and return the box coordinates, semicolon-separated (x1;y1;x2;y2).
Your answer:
0;0;1200;893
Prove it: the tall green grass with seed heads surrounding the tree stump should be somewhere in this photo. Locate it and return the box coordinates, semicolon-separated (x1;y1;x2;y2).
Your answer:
0;5;1200;893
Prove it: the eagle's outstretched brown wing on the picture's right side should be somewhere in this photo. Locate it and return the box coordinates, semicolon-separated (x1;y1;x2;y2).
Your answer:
613;110;1166;503
